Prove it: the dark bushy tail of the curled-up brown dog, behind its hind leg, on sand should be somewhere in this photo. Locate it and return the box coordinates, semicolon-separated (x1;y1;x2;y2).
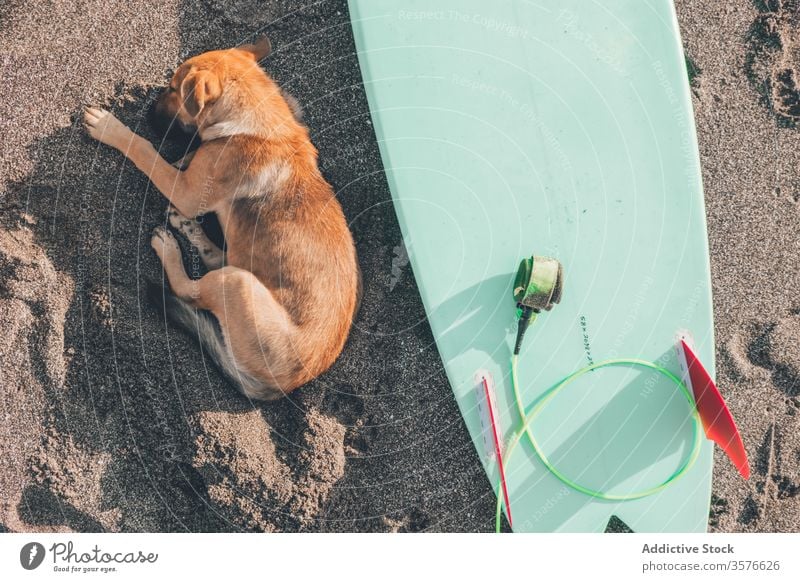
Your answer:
147;281;284;400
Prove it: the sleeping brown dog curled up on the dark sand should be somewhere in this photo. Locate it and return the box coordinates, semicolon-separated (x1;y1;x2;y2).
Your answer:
84;38;360;400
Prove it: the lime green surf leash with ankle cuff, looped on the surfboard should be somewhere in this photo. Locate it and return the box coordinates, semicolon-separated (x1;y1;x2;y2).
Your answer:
495;257;703;533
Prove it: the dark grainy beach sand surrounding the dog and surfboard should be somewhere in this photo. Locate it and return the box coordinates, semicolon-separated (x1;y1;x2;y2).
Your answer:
0;0;800;531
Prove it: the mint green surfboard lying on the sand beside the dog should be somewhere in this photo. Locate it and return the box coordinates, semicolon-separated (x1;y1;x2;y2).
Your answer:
350;0;714;532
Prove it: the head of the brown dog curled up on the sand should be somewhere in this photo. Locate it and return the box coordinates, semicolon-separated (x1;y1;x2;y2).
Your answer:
153;36;272;137
